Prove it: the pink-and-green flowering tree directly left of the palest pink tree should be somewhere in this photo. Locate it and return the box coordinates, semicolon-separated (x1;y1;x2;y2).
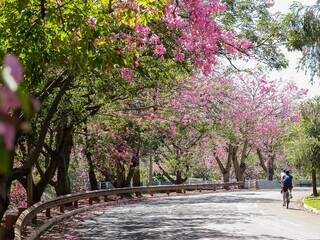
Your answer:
131;77;229;184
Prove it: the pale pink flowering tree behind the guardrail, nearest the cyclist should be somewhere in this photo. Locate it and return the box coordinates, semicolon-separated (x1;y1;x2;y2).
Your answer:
216;75;306;181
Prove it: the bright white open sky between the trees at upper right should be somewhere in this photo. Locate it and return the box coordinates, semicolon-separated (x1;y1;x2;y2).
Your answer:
270;0;320;97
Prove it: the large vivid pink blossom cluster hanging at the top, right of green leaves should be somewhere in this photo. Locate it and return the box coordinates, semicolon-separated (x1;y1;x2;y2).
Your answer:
165;0;247;75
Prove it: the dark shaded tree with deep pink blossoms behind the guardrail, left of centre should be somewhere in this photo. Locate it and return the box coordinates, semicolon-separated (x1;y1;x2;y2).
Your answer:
85;118;150;187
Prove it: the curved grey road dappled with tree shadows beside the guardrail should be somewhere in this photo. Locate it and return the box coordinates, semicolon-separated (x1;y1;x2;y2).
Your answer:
43;190;320;240
